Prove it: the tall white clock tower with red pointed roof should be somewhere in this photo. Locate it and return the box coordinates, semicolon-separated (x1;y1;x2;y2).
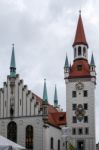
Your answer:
64;12;96;150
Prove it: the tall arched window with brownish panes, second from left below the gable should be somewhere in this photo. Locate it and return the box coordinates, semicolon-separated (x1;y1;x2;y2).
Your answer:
26;125;33;150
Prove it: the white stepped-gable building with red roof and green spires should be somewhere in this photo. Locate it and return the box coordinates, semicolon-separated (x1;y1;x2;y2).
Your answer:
0;45;66;150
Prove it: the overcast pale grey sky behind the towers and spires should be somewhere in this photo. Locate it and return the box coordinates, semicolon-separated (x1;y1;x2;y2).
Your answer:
0;0;99;142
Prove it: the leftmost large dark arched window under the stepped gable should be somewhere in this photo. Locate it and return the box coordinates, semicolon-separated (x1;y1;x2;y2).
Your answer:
7;121;17;142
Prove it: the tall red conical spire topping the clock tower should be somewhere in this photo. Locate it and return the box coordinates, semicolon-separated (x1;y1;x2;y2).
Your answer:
73;10;88;47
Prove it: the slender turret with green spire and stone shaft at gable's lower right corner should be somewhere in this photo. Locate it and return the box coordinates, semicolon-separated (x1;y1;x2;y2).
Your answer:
42;79;48;122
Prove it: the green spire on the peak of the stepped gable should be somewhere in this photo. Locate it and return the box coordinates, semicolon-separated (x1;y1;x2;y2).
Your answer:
10;44;16;77
